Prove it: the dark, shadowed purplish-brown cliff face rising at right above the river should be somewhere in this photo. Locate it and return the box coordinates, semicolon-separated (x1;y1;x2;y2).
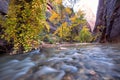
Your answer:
94;0;120;42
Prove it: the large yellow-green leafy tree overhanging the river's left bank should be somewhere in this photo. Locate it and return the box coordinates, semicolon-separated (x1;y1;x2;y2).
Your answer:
1;0;49;51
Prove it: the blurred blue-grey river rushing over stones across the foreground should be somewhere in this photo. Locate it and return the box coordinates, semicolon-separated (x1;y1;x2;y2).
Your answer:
0;44;120;80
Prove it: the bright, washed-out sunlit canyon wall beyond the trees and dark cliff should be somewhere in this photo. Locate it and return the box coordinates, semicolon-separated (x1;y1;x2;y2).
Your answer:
63;0;98;31
